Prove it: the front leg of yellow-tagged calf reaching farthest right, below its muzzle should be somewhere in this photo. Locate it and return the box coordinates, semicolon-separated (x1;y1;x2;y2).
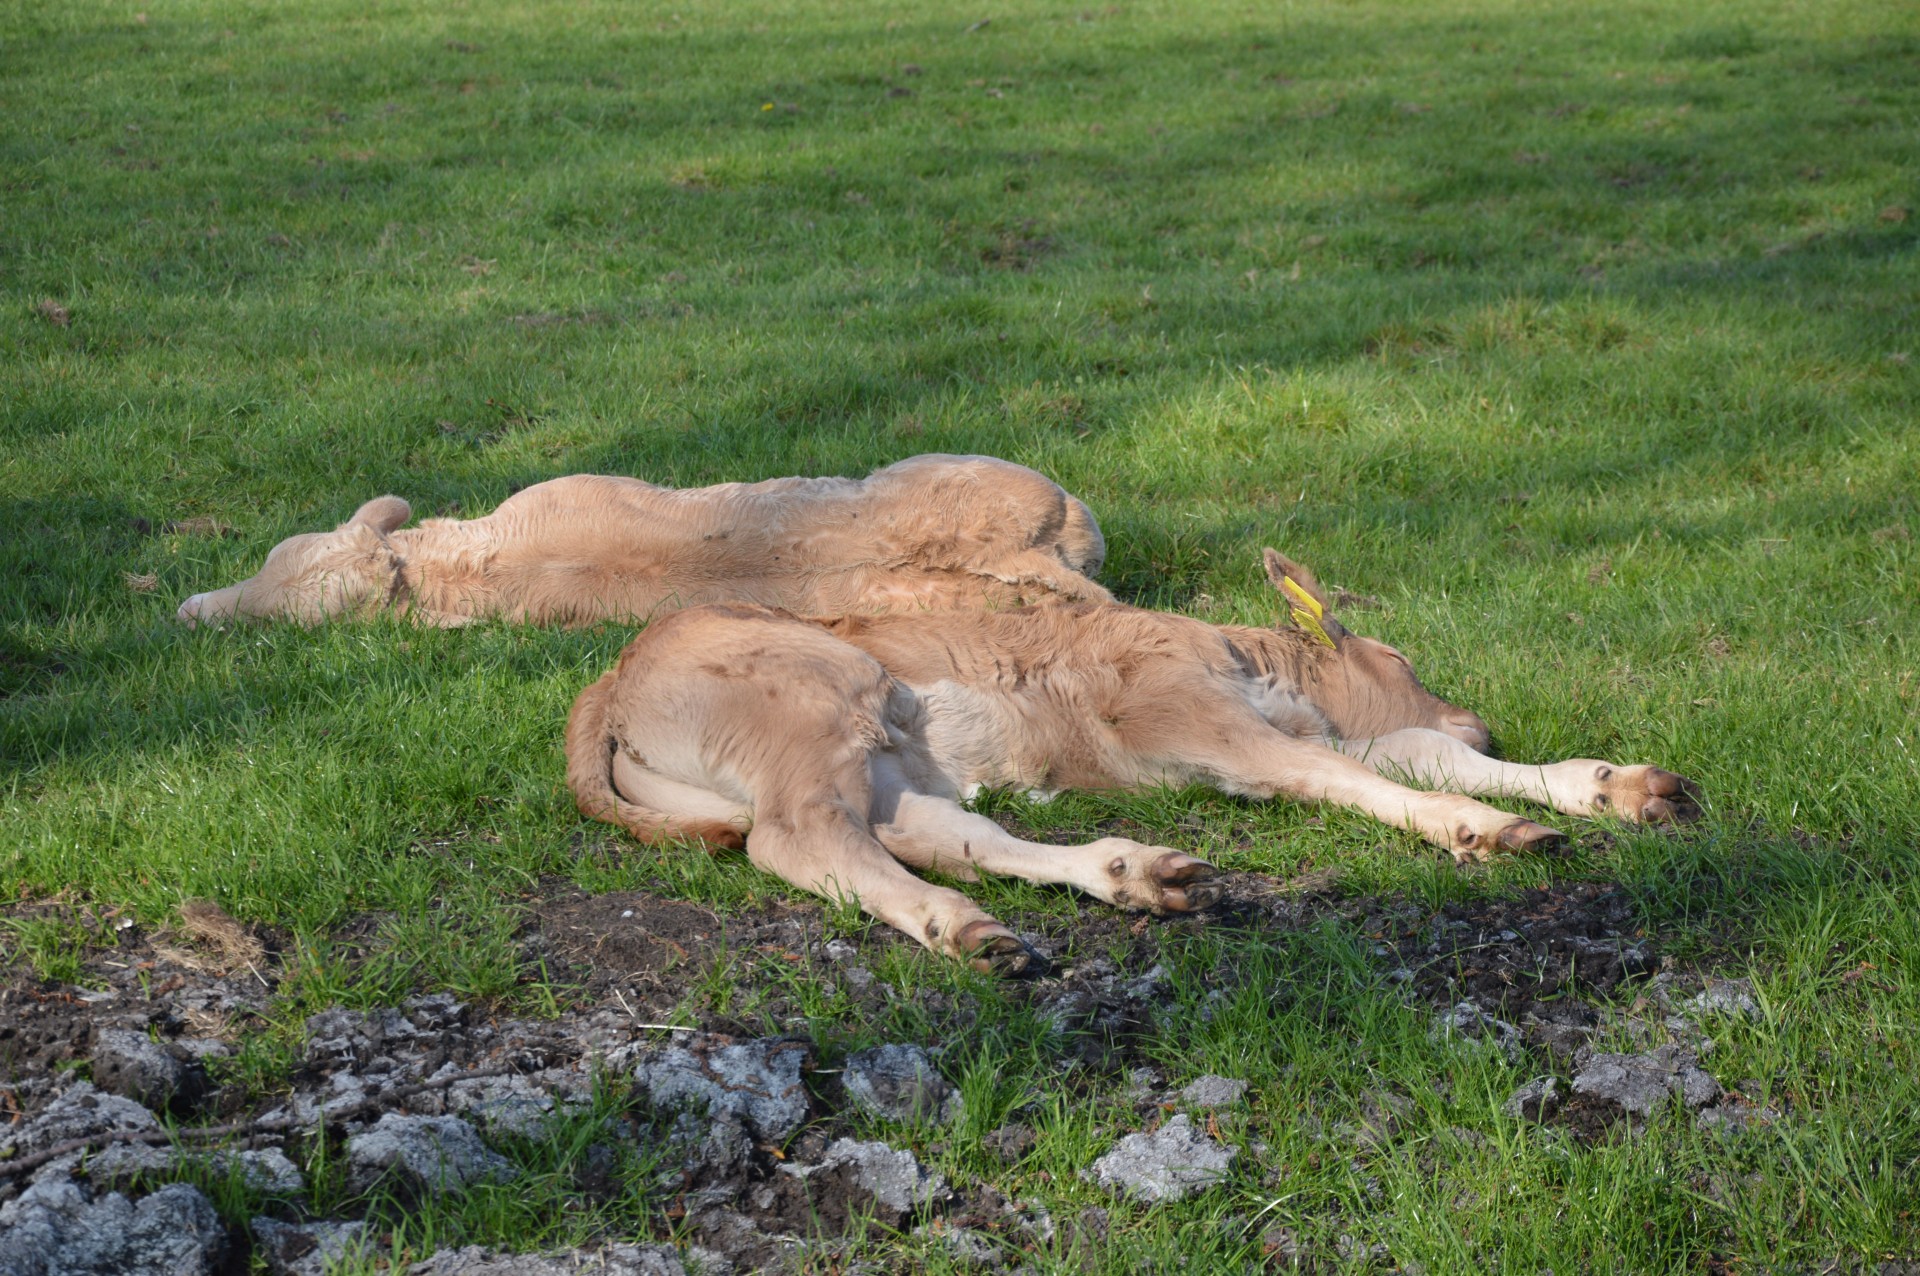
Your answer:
1340;727;1699;823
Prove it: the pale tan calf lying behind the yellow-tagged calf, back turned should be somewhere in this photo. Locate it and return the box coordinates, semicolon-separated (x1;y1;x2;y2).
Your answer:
179;455;1112;626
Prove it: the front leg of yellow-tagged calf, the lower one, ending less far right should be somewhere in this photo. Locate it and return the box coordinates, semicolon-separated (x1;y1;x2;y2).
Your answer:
1156;717;1567;862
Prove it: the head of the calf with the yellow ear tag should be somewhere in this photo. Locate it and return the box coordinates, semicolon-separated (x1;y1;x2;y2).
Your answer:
1265;549;1492;750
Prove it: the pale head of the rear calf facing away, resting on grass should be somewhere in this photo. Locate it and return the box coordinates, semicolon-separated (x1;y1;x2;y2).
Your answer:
177;497;413;626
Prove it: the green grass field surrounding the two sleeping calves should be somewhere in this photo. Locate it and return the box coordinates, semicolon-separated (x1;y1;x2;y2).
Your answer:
0;0;1920;1274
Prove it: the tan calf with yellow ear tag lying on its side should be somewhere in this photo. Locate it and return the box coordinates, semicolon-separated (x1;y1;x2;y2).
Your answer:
566;551;1695;973
